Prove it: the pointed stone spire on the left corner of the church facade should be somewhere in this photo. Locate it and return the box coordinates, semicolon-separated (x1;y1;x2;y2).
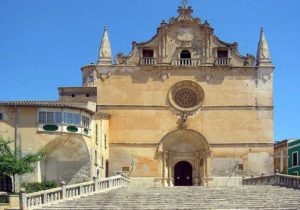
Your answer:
98;27;112;65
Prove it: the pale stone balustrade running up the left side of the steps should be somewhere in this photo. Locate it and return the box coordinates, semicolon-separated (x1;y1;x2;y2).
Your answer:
20;174;129;210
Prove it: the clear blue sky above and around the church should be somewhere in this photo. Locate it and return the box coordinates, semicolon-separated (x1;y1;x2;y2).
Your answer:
0;0;300;140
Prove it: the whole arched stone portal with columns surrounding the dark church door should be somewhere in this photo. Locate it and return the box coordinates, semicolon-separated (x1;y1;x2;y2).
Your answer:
157;129;210;186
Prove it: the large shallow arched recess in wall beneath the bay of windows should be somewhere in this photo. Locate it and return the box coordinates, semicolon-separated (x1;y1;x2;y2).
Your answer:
41;134;91;183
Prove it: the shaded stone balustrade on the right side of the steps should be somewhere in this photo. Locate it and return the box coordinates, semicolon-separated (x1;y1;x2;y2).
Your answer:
242;174;300;189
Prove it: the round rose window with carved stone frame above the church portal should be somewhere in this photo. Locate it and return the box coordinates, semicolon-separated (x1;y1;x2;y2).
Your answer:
169;81;204;112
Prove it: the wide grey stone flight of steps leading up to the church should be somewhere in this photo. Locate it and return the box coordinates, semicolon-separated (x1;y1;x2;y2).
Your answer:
34;186;300;210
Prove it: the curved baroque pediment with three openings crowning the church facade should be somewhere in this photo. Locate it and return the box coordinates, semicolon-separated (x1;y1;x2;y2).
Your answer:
115;4;254;67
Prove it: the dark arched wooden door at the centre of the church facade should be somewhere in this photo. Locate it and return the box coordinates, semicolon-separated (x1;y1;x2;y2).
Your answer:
173;161;193;186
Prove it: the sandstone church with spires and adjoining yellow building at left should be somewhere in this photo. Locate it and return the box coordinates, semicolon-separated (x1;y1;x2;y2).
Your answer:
0;4;274;189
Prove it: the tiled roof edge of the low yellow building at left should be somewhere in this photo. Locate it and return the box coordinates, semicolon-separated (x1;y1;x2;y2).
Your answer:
0;101;96;113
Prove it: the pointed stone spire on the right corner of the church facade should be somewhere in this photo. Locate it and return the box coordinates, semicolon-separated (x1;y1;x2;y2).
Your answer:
256;28;273;66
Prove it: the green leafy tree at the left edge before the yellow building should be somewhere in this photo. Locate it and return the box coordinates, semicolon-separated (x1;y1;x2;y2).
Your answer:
0;136;46;191
